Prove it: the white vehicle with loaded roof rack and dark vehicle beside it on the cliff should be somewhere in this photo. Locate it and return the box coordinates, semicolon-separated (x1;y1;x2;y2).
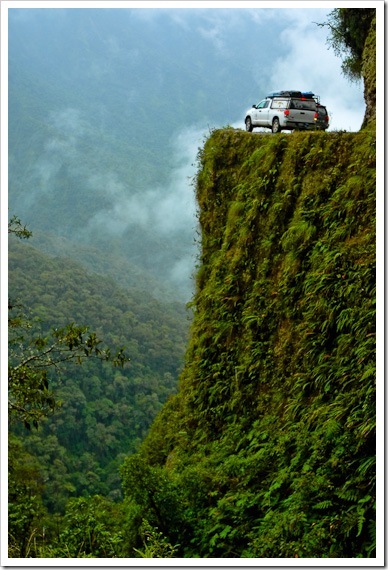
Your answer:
245;91;329;133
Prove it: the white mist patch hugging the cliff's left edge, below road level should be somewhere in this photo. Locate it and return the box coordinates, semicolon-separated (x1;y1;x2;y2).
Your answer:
83;121;206;298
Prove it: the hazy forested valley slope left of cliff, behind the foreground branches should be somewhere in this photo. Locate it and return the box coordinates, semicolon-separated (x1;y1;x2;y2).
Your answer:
9;238;189;513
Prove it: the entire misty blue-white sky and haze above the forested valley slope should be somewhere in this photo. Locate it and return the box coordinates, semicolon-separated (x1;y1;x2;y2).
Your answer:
8;6;364;301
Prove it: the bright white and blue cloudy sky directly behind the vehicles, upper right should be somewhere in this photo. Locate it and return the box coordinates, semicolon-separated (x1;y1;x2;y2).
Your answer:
128;1;365;131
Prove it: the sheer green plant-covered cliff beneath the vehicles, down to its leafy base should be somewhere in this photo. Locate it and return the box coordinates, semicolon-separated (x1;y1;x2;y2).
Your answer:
123;18;376;558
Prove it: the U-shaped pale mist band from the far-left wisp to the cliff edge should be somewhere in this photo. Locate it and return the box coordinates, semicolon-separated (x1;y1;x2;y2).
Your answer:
30;103;204;258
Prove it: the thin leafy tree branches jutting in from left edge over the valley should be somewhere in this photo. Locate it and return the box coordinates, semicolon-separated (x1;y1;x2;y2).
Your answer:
8;216;129;429
